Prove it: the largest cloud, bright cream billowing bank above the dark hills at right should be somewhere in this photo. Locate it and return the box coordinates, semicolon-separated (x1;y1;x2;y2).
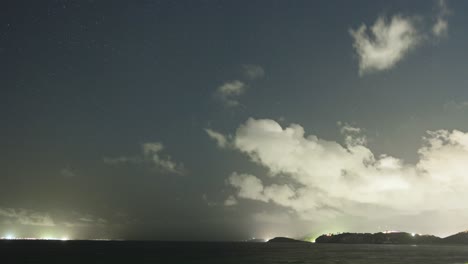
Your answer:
215;118;468;219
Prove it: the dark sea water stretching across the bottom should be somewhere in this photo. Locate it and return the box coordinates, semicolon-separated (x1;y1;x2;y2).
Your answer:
0;241;468;264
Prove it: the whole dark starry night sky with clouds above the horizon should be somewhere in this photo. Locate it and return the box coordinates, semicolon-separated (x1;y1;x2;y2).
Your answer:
0;0;468;240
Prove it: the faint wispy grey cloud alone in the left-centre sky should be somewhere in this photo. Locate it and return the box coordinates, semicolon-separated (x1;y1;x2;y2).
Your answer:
103;142;186;174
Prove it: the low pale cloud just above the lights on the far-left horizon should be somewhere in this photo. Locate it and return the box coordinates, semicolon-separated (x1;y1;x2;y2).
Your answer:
0;208;55;226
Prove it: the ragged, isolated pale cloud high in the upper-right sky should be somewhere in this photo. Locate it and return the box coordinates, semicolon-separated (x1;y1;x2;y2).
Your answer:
349;15;420;75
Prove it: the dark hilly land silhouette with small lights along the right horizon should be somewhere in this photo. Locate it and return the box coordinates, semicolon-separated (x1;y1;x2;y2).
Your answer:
267;231;468;245
